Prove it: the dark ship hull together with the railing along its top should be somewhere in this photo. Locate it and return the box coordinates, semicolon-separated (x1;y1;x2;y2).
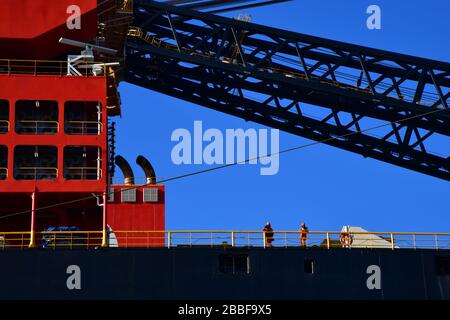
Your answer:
0;227;450;300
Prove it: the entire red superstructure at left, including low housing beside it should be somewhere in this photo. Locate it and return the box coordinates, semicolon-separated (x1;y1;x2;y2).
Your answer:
0;0;165;246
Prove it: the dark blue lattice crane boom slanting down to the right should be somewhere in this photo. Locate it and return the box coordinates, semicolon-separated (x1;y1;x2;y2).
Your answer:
123;0;450;180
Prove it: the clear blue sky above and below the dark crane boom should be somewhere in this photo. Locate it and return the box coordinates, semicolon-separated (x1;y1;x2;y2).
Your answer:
116;0;450;231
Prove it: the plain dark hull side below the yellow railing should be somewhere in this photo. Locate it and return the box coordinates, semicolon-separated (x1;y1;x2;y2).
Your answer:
0;247;450;300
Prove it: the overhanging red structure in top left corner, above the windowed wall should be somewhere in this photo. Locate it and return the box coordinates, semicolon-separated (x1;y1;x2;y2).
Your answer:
0;0;97;59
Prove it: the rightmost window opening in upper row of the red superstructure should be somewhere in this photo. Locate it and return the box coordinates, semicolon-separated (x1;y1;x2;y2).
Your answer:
64;101;102;135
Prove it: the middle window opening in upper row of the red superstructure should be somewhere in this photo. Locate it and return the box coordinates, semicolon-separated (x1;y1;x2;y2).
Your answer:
16;100;59;134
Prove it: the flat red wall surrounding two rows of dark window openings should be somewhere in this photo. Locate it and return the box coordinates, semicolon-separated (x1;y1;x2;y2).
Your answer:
0;75;108;193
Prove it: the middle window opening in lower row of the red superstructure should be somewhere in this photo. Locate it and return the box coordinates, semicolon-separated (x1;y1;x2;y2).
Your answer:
14;146;58;180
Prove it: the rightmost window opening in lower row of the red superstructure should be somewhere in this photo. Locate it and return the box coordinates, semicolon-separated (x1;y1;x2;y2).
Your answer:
64;146;102;180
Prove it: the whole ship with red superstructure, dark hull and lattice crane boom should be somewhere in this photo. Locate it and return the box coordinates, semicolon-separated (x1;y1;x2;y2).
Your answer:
0;0;450;299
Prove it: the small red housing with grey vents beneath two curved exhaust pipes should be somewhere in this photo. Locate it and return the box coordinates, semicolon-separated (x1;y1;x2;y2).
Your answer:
107;185;165;246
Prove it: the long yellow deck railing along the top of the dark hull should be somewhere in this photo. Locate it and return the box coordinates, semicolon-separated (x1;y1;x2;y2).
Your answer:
0;230;450;250
